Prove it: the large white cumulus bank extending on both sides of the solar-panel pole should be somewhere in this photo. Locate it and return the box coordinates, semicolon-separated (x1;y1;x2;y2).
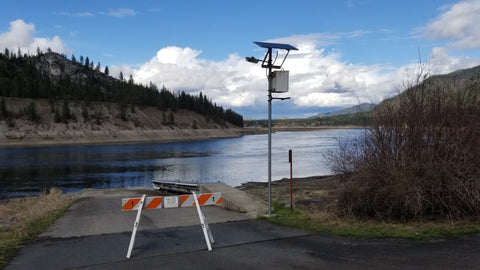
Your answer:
117;34;402;110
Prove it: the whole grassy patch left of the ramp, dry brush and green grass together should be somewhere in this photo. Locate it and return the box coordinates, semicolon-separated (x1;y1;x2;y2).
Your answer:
0;190;72;269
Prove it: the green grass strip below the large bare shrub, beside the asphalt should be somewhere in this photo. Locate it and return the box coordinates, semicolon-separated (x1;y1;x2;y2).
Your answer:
262;202;480;240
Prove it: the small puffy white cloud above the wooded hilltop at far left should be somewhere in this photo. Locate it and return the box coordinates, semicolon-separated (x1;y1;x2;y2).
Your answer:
0;20;70;54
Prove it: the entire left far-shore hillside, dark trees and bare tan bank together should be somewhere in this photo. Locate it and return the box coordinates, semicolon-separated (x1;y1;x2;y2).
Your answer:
0;50;249;144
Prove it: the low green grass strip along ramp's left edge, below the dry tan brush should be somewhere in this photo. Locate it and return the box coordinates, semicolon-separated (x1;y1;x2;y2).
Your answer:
0;202;71;269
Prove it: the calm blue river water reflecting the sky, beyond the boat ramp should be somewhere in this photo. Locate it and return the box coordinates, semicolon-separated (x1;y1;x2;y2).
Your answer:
0;130;362;197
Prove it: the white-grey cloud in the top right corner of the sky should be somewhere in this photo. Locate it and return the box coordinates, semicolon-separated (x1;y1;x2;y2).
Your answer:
425;0;480;49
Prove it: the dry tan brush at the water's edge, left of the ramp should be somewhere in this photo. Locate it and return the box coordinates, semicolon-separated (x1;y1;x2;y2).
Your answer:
0;189;69;230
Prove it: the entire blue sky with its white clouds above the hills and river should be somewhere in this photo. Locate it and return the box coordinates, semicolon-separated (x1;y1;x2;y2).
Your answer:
0;0;480;119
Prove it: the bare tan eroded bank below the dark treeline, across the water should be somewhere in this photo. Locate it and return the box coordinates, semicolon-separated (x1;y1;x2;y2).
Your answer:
0;97;255;145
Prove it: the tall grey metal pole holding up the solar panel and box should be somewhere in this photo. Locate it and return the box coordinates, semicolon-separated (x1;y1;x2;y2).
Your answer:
268;48;272;217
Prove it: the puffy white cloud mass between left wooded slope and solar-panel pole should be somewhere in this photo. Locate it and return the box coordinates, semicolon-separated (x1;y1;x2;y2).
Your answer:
127;46;265;106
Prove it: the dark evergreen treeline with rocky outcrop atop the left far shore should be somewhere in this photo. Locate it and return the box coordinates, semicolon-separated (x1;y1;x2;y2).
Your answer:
0;49;243;127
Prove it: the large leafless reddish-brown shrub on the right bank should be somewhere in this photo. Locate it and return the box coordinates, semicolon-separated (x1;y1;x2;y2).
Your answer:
331;77;480;220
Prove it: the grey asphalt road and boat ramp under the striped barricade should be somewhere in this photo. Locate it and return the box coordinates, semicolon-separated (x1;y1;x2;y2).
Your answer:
7;187;480;269
